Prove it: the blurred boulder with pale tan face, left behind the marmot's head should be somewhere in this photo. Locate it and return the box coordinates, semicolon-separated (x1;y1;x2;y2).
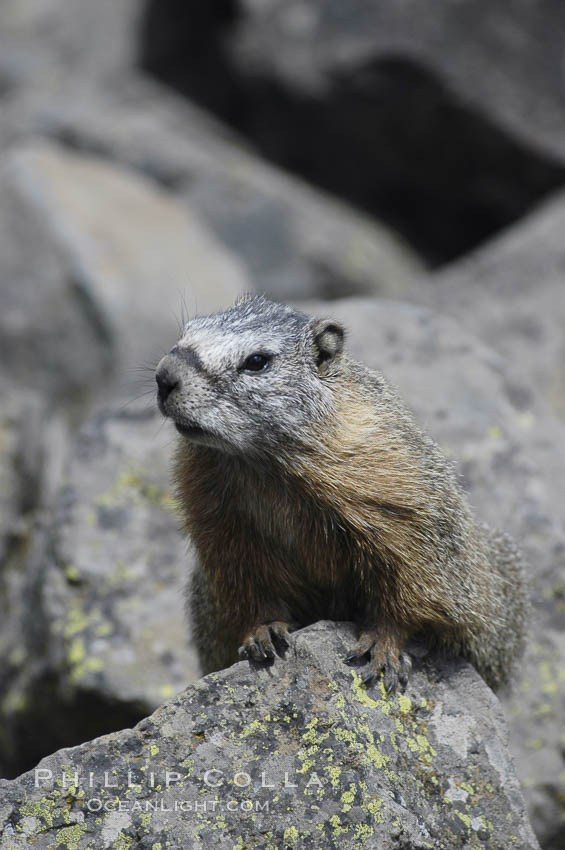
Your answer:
0;140;249;404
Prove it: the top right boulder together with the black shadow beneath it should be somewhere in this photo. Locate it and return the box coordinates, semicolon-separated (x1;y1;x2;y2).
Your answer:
140;0;565;264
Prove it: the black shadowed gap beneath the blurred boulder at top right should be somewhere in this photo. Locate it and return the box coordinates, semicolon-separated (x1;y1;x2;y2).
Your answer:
139;0;565;266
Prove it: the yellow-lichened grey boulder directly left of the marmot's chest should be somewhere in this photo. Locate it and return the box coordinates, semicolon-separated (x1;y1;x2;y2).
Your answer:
43;405;199;713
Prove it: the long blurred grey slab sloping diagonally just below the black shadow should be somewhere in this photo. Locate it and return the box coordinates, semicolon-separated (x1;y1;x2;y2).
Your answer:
0;76;422;299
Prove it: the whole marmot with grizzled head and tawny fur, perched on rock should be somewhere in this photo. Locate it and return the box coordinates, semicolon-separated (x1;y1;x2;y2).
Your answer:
156;296;527;690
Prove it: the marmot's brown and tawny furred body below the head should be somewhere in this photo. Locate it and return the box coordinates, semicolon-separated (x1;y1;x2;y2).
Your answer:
176;355;526;688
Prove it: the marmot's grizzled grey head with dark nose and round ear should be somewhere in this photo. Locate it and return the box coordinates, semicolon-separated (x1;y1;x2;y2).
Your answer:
155;296;344;453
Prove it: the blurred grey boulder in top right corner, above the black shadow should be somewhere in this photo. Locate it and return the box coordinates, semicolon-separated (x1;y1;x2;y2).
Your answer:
223;0;565;161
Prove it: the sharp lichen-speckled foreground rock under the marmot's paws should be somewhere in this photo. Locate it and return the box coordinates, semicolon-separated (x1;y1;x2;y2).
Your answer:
0;624;538;850
